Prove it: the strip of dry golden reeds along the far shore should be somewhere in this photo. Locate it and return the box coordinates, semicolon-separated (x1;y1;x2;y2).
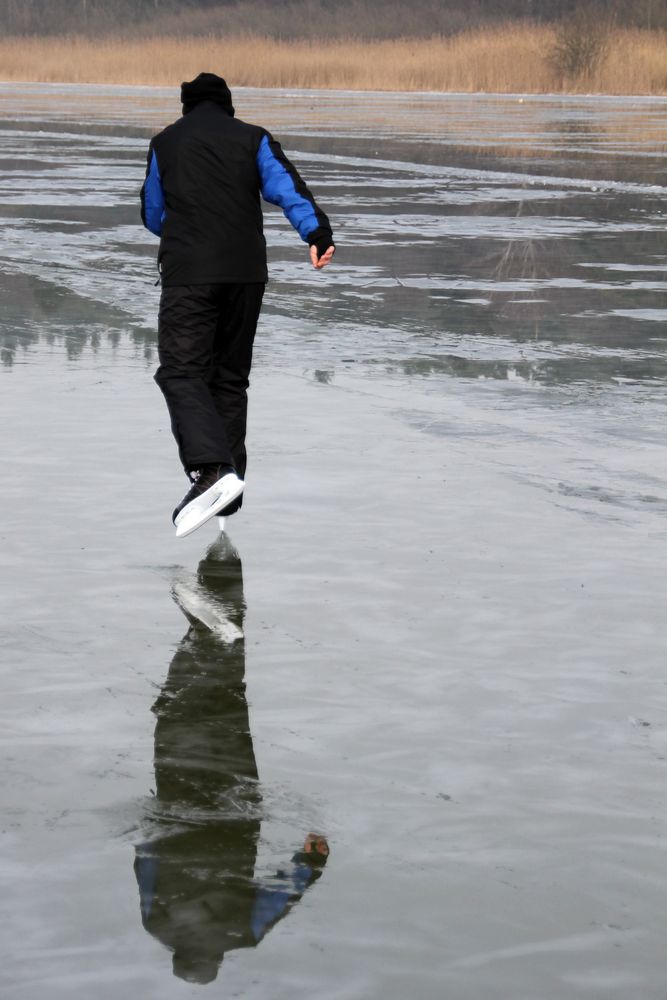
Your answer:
0;25;667;94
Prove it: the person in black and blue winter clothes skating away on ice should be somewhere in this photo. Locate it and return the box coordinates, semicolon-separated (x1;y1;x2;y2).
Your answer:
141;73;334;535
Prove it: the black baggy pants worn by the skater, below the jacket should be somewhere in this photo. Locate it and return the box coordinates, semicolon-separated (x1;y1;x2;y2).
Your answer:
155;282;265;478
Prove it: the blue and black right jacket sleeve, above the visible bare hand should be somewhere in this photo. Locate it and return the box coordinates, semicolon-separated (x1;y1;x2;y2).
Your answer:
257;133;333;243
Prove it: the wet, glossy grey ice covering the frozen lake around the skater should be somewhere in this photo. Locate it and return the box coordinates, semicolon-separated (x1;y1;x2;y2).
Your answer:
0;85;667;1000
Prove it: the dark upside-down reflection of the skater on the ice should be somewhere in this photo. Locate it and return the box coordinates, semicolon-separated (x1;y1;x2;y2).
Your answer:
135;535;328;983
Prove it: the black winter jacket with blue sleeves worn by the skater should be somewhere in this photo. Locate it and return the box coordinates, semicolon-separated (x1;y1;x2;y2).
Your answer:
141;100;333;285
